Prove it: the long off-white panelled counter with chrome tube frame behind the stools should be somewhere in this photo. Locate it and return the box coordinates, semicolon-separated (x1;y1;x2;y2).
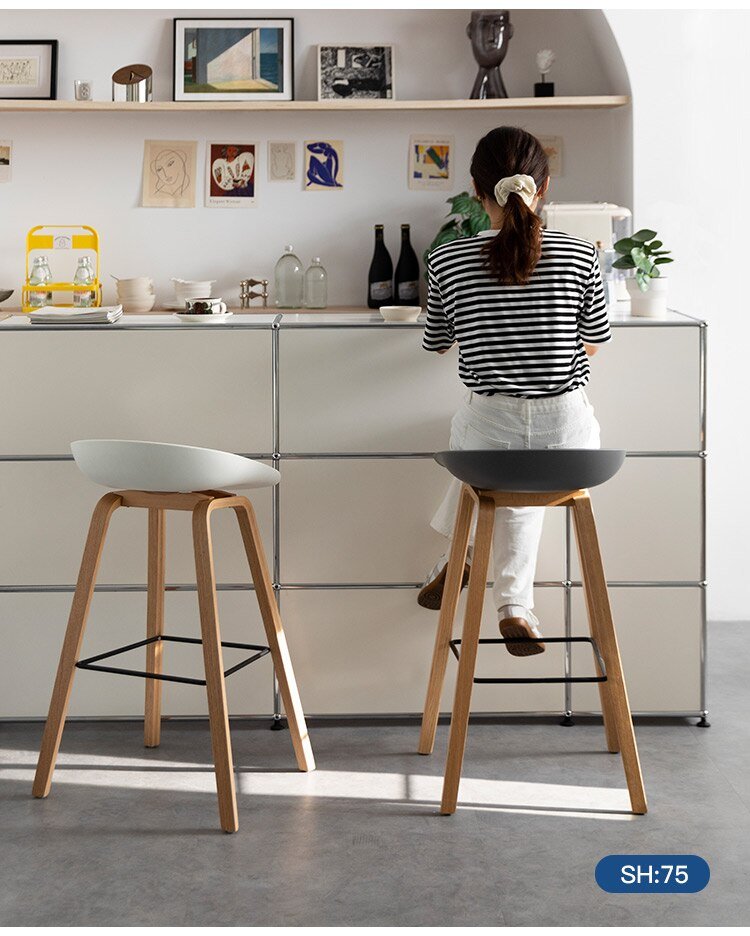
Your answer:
0;309;706;717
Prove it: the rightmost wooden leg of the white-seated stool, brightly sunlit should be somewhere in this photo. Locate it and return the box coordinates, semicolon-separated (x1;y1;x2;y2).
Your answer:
234;498;315;770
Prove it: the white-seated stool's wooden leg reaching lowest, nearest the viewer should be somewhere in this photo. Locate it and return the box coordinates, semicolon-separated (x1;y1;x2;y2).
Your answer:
193;501;239;832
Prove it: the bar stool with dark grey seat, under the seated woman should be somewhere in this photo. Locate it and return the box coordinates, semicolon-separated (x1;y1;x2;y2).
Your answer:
419;449;647;815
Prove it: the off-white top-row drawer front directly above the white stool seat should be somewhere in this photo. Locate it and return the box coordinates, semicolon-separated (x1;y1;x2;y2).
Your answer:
0;326;272;455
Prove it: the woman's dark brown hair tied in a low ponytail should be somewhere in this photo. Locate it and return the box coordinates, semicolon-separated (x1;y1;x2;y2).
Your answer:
471;127;549;286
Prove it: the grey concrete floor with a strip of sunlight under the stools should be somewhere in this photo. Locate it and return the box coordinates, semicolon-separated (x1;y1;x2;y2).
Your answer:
0;624;750;926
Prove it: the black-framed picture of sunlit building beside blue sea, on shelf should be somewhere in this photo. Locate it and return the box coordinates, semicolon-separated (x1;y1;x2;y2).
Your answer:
172;18;294;101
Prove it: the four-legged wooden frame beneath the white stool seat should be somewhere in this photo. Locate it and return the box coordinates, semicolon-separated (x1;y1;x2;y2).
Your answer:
33;491;315;832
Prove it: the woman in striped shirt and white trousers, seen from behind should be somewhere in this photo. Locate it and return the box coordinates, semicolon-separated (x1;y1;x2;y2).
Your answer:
418;127;611;656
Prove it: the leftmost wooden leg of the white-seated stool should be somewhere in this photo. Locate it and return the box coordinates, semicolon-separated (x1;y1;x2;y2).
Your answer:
32;494;121;797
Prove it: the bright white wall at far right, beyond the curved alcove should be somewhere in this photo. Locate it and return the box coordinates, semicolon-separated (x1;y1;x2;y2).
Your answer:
606;10;750;620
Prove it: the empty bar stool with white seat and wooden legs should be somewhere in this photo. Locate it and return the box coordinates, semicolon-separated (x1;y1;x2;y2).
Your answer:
33;439;315;832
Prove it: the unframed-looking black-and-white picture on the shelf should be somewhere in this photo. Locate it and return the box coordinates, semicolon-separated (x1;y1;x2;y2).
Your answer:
318;45;395;101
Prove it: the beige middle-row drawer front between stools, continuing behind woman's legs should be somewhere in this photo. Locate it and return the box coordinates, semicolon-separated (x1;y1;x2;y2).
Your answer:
281;459;565;583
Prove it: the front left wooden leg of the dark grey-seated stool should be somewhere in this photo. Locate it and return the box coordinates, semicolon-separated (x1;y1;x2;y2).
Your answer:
440;496;495;816
